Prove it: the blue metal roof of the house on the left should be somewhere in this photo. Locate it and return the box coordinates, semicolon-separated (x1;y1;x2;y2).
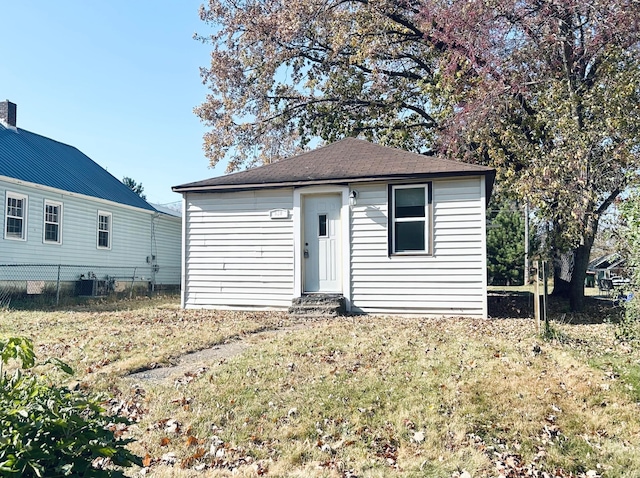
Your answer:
0;124;155;211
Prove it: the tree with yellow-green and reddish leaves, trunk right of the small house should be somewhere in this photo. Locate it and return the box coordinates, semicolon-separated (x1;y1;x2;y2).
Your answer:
426;0;640;310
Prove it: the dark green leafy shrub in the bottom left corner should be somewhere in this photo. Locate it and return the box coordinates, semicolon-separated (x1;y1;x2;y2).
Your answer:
0;337;140;478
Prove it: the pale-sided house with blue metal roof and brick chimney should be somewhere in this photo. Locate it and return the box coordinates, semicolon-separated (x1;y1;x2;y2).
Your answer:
0;101;182;285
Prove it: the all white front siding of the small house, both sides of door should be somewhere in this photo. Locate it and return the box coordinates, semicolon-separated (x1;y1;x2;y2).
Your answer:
178;177;486;317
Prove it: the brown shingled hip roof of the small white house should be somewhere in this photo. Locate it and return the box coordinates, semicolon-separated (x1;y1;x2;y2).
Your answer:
172;138;495;192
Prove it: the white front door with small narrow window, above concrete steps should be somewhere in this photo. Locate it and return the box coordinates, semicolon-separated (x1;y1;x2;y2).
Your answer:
303;194;342;292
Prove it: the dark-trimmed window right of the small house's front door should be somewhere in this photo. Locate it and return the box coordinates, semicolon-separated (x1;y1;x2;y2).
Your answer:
390;183;431;254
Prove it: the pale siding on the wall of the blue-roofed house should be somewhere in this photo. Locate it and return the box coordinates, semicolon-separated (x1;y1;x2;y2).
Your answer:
0;179;181;285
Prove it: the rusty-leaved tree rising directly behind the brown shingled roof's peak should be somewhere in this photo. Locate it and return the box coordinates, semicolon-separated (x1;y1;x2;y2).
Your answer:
196;0;440;171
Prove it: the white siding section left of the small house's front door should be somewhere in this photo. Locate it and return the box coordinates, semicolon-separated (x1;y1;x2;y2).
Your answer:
184;189;294;309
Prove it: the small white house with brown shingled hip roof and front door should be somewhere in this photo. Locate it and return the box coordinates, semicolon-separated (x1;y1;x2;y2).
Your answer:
173;138;495;317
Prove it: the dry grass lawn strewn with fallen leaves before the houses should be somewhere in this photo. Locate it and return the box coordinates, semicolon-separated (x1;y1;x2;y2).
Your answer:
0;299;640;477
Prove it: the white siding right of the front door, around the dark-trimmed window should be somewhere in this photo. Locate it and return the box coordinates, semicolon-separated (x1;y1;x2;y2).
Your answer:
351;178;486;317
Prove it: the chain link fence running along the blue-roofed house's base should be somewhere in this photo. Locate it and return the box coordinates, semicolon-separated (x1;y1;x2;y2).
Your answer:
0;264;180;308
